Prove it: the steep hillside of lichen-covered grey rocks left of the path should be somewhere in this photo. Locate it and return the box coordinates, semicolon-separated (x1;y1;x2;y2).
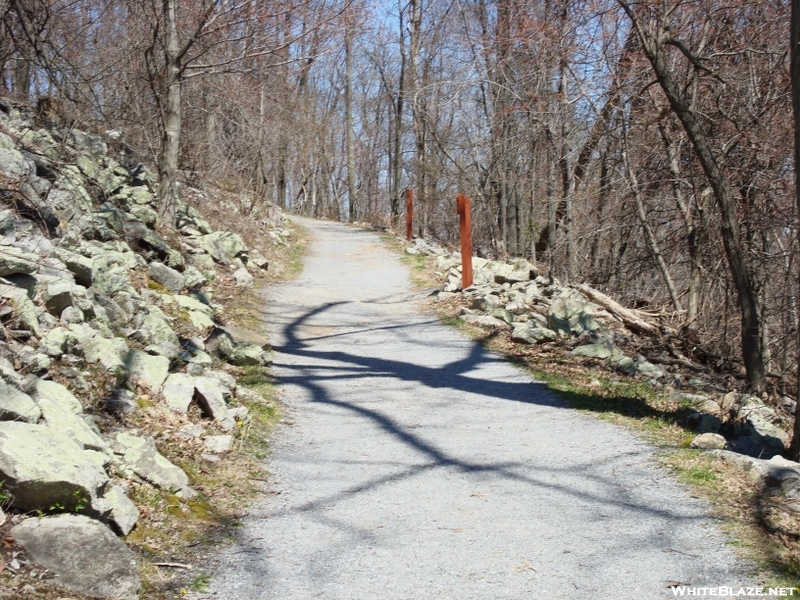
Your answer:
0;99;288;598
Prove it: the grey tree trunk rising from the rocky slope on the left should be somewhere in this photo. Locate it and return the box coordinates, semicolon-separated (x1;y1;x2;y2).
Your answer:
158;0;182;228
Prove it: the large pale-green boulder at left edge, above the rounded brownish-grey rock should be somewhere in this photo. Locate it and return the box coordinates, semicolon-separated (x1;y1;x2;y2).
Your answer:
0;421;108;511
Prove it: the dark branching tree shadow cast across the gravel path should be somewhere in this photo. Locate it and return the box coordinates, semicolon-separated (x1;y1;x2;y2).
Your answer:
216;298;752;592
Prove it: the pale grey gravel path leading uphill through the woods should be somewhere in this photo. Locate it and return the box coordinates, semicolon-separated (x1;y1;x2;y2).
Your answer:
200;219;747;600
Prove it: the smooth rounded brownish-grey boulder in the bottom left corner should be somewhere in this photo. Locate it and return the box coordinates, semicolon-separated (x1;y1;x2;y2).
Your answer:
10;515;141;600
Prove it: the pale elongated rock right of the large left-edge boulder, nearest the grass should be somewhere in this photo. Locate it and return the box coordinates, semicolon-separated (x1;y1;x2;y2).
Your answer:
113;431;194;497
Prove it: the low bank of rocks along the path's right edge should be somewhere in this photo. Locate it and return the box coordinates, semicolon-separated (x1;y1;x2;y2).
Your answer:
406;239;800;499
